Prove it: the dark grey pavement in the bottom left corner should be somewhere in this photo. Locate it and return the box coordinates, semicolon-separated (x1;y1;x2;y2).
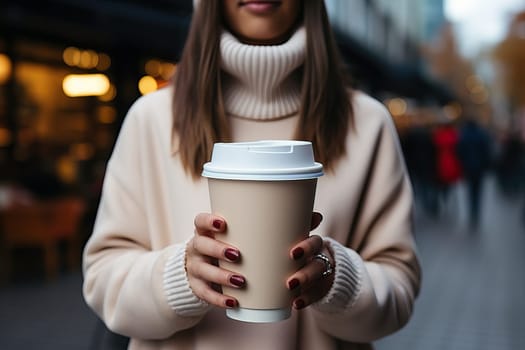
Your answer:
0;272;97;350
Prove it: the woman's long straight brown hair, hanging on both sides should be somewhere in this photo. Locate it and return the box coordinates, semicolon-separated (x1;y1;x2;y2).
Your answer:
173;0;353;178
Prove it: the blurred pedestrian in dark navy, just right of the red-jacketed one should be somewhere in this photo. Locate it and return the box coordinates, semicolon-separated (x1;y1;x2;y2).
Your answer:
457;118;492;232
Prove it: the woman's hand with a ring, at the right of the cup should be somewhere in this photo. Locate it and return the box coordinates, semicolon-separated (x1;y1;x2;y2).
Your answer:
286;213;335;309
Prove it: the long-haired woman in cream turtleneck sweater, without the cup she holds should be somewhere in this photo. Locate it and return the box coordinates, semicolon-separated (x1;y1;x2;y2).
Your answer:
84;0;420;350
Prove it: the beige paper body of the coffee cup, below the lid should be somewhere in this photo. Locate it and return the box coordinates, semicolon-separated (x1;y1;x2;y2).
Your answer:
208;178;317;310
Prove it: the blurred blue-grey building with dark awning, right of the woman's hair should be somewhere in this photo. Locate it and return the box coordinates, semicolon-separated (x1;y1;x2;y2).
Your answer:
326;0;457;129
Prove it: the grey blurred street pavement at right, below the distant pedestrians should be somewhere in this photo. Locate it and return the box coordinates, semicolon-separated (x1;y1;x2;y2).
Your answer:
376;178;525;350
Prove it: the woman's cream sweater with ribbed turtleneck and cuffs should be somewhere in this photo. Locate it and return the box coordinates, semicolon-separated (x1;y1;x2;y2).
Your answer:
83;29;420;350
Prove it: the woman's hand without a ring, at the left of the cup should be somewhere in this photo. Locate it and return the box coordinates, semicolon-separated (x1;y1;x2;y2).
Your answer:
186;213;246;308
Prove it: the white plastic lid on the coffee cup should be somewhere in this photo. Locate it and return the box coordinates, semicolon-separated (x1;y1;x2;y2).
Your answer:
202;140;323;181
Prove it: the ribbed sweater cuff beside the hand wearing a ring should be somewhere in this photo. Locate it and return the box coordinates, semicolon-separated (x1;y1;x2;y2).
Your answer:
313;237;364;313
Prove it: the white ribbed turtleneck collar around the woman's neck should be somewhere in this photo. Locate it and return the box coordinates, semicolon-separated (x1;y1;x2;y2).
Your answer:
221;27;306;120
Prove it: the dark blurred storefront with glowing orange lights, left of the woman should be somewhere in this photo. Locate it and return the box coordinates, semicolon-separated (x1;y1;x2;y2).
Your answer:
0;0;193;284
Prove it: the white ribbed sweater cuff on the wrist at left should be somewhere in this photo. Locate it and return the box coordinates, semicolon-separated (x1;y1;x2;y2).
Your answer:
163;244;209;317
